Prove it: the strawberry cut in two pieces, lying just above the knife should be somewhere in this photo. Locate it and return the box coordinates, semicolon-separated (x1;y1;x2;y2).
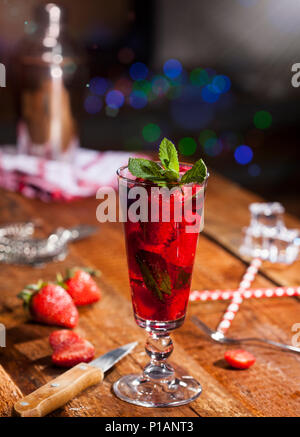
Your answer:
49;329;95;367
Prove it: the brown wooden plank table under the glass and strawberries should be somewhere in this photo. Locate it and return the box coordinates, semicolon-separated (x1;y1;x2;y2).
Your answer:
0;175;300;417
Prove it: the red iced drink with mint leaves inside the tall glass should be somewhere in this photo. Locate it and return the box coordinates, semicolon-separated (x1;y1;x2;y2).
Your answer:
125;166;203;322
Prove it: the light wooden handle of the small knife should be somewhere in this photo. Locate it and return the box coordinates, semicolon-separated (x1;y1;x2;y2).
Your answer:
14;363;103;417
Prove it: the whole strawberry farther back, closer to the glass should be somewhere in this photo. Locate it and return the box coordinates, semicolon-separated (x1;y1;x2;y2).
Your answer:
58;267;101;306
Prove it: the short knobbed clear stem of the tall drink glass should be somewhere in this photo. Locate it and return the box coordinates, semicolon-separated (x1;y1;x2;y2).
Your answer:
144;331;174;383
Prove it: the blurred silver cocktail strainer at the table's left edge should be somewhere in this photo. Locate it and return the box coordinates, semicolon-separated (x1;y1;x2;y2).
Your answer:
0;222;97;265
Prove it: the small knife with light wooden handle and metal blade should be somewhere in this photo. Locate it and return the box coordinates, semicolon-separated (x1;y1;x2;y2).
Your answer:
14;341;138;417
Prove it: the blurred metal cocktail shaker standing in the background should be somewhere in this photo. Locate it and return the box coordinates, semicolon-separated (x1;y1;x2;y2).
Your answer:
15;3;84;161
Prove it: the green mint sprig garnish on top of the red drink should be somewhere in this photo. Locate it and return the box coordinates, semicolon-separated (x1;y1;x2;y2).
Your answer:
128;138;207;187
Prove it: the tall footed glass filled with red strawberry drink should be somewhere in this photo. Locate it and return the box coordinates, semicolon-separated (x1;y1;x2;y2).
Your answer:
113;164;206;407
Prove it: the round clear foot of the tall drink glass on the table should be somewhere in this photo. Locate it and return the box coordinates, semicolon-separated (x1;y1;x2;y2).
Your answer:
113;375;202;408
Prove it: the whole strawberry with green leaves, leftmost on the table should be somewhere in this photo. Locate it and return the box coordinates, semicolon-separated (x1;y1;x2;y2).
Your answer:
18;281;78;328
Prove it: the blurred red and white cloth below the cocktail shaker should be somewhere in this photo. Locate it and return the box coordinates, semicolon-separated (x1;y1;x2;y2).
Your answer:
0;147;142;201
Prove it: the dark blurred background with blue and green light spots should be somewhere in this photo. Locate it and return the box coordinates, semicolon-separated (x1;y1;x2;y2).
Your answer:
0;0;300;216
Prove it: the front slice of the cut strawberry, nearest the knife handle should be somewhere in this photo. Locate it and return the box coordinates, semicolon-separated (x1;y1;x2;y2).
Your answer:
52;339;95;367
